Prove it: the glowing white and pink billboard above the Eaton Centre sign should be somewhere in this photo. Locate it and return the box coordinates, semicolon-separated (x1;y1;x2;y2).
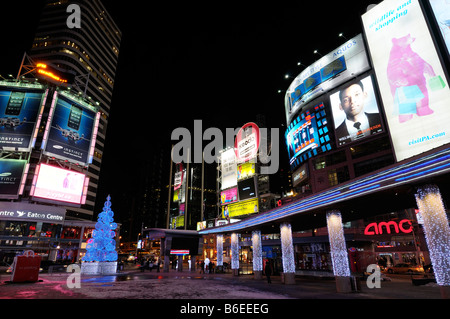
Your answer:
30;164;89;204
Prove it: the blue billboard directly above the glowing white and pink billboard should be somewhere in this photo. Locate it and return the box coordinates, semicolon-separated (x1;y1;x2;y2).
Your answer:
41;93;100;165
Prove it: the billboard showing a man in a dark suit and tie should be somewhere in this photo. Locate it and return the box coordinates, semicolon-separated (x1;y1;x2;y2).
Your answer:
330;75;383;146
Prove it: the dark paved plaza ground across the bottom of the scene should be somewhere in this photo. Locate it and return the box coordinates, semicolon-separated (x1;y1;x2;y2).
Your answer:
0;268;441;299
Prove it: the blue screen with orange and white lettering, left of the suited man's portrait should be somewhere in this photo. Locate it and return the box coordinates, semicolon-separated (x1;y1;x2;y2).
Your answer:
285;103;332;168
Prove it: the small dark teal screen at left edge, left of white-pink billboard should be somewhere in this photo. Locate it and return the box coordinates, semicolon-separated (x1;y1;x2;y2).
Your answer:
0;159;27;199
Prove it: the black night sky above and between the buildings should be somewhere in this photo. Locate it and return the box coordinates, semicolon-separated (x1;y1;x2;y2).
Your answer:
0;0;378;222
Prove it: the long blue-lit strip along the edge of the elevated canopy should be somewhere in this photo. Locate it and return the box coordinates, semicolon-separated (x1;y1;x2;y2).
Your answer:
199;149;450;235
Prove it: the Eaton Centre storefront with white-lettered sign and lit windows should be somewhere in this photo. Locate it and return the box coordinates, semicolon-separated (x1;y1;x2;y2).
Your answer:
0;202;120;263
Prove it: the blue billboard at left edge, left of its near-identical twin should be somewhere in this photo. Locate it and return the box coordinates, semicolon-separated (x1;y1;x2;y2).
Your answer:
0;86;47;152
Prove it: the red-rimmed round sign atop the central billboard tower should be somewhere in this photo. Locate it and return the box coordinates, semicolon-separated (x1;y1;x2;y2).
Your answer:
234;122;260;162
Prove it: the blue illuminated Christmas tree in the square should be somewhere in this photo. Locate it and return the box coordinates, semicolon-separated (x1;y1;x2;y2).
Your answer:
83;195;117;261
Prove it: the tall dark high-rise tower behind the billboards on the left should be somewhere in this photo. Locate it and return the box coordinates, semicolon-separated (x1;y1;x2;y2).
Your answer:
29;0;122;219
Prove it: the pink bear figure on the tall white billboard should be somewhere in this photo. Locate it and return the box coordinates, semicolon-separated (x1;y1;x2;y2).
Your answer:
387;34;435;123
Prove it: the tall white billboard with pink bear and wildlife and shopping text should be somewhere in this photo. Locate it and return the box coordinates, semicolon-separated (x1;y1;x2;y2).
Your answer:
362;0;450;161
